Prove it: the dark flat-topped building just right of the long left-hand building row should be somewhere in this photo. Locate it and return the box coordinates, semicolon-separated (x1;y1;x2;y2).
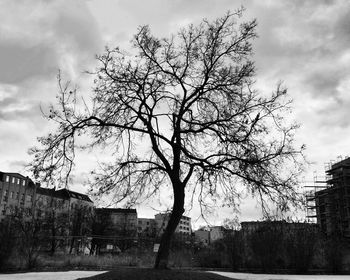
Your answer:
96;208;137;237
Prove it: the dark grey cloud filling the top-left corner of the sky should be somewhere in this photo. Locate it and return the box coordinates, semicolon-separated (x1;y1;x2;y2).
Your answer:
0;0;103;84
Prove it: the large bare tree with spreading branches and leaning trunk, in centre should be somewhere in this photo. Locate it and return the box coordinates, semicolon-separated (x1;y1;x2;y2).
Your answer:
32;10;300;267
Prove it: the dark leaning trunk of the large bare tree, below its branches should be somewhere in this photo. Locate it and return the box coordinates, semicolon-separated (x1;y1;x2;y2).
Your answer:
154;183;185;269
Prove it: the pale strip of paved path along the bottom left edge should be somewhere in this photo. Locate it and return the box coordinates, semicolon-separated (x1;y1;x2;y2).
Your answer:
0;271;105;280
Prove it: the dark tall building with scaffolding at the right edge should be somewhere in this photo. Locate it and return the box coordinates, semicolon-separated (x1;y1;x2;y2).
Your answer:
315;158;350;237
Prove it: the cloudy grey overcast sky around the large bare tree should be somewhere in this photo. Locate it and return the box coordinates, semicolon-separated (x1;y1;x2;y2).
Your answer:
0;0;350;225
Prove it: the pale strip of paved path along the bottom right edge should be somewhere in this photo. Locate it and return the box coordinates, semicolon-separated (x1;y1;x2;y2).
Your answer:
210;271;350;280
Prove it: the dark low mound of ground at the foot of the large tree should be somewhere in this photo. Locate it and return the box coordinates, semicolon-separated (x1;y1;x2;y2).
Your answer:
80;267;232;280
